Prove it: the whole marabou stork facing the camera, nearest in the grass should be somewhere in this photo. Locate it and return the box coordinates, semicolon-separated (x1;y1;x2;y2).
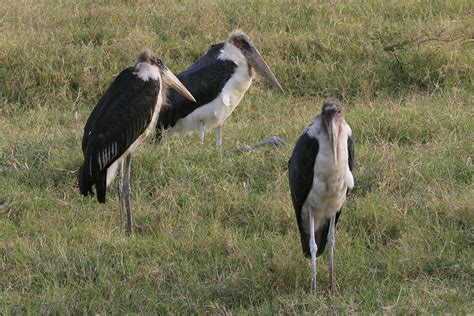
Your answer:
288;101;354;291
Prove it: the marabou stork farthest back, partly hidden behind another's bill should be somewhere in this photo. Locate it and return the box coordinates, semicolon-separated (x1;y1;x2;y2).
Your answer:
157;30;283;148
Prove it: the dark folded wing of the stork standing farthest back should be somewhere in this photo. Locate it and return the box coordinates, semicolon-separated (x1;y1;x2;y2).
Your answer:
156;43;237;137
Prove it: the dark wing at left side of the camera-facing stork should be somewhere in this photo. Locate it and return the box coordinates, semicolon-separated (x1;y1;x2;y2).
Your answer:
288;132;319;256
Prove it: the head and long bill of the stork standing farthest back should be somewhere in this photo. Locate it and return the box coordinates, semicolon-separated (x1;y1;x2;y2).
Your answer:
227;30;283;92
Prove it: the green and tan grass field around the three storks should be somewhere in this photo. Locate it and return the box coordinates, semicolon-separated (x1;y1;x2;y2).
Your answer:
0;0;474;315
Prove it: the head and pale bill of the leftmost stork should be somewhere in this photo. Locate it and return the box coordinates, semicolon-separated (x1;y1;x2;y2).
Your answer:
135;48;196;102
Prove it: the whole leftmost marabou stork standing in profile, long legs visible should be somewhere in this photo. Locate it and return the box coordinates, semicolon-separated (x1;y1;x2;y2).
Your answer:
79;49;194;234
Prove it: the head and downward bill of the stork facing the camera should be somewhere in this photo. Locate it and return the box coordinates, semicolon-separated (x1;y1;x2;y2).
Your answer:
321;100;344;166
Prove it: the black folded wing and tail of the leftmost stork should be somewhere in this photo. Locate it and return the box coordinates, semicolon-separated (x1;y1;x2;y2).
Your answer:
79;68;159;202
